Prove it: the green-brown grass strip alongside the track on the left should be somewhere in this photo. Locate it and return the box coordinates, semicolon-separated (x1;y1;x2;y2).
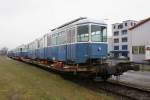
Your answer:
0;57;115;100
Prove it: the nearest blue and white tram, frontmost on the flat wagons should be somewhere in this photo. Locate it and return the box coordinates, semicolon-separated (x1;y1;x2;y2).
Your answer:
46;18;107;64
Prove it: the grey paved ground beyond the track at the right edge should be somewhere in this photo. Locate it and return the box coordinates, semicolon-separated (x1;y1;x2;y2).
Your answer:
110;71;150;89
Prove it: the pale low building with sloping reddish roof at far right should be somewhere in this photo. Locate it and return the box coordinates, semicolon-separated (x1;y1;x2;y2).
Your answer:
129;17;150;62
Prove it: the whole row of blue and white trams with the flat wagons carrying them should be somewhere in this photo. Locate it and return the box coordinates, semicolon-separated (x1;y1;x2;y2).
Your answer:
8;18;138;80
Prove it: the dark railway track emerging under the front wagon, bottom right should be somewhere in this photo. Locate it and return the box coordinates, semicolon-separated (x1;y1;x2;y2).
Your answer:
68;79;150;100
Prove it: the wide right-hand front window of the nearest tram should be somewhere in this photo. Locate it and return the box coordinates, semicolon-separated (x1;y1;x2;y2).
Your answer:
91;25;107;42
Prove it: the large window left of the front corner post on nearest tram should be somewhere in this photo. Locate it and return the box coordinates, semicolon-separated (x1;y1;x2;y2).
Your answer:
77;25;89;42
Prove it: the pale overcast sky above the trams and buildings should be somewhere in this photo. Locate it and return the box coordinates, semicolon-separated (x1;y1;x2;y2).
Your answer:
0;0;150;48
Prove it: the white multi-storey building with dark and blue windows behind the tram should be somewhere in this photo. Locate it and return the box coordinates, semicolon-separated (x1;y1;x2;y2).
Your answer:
112;20;137;58
